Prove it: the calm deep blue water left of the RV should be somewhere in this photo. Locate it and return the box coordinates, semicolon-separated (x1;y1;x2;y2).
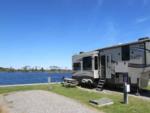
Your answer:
0;72;72;85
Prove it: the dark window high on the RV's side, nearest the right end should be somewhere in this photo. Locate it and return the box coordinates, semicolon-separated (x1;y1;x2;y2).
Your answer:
121;45;130;61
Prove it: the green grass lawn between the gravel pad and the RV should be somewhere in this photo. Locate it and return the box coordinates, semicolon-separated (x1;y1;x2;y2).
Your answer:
0;84;150;113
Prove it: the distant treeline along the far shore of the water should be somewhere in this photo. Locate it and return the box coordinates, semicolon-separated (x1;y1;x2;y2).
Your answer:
0;66;72;73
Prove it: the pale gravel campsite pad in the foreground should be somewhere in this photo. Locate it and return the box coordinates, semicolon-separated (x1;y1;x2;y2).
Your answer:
0;90;101;113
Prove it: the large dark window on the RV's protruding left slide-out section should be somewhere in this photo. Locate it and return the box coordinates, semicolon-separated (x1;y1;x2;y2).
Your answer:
83;57;92;70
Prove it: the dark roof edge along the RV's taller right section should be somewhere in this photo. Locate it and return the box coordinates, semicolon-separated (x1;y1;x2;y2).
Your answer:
96;37;150;51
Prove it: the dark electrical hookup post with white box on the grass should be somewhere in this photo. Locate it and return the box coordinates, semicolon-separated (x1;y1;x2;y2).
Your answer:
123;82;130;104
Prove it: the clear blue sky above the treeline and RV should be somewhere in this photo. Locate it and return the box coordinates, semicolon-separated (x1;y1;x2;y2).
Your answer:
0;0;150;68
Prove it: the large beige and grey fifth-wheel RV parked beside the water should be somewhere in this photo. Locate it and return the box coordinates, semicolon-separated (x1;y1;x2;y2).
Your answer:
72;37;150;90
